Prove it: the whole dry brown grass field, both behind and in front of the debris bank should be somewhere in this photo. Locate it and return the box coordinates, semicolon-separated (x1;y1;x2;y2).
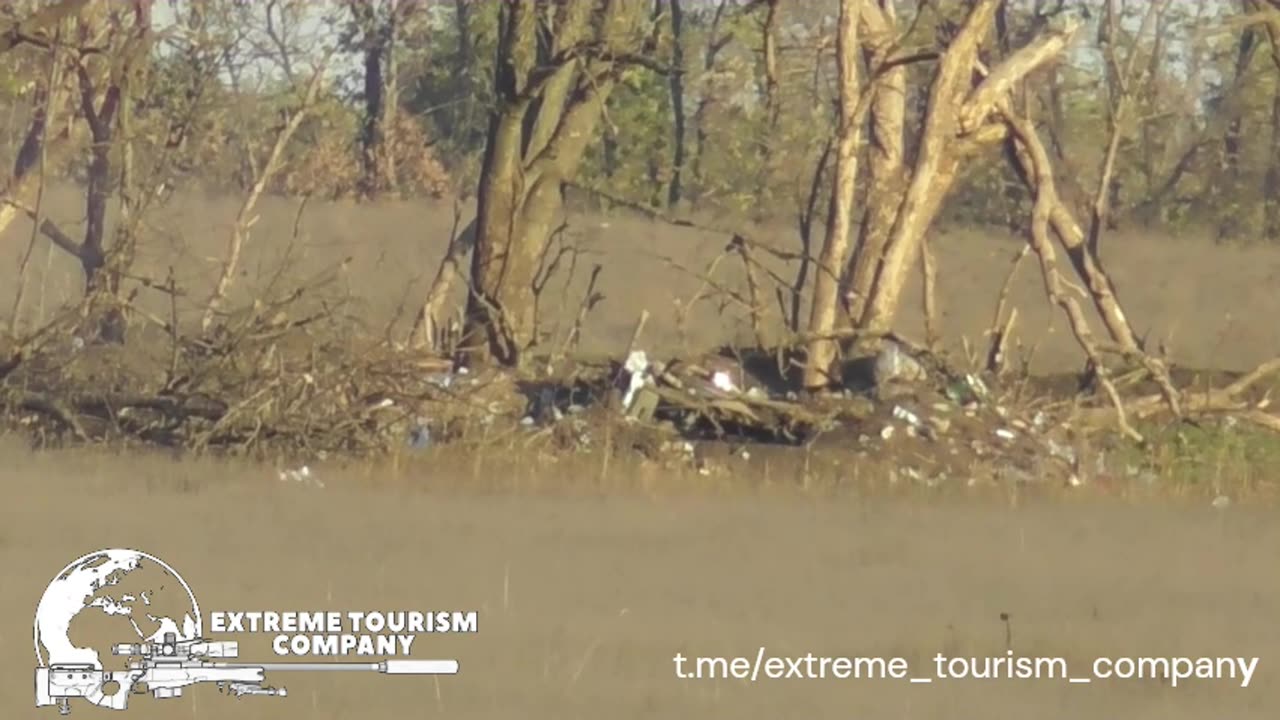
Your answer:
0;190;1280;720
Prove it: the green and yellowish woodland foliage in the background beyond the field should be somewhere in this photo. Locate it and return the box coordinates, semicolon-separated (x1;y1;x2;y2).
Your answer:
0;0;1280;242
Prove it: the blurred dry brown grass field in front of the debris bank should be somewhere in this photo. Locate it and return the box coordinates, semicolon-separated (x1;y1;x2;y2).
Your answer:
0;445;1280;720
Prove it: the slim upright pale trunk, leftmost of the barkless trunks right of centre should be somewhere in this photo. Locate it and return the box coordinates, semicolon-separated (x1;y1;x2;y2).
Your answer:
803;0;864;389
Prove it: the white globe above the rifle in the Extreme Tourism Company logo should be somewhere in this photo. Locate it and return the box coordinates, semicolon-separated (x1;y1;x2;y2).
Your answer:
35;548;204;670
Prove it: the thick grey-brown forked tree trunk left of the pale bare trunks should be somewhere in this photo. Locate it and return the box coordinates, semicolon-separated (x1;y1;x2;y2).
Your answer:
462;0;652;366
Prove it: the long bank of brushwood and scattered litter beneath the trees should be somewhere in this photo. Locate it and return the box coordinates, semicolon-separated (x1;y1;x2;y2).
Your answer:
0;298;1265;491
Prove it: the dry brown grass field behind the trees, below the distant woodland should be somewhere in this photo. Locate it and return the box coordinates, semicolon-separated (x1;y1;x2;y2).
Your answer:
0;181;1280;373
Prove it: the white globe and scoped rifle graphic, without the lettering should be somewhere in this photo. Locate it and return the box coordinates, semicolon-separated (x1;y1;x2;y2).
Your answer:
35;548;458;715
